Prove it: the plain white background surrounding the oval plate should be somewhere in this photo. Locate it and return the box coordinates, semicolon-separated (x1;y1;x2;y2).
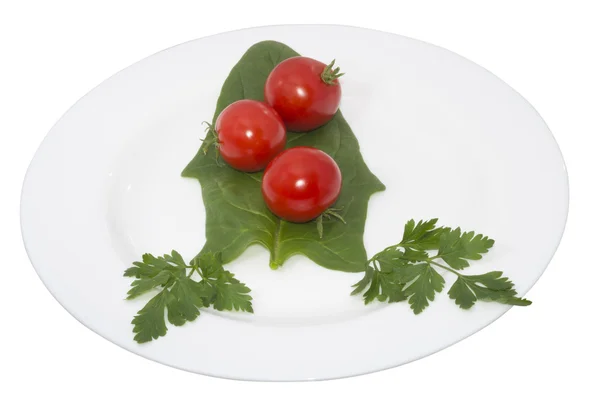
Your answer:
0;0;600;400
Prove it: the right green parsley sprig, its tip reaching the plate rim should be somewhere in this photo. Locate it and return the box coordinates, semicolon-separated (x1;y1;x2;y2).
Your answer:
351;219;531;314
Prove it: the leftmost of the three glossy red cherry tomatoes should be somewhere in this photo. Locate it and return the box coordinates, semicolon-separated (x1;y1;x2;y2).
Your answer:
215;100;286;172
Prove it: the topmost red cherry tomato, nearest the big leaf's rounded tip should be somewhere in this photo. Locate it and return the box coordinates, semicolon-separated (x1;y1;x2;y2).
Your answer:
265;57;342;132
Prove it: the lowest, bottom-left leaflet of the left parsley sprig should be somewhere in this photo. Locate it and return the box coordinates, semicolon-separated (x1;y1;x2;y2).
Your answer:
131;289;171;343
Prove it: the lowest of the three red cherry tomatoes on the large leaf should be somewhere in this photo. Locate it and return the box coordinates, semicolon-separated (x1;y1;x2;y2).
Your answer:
262;147;342;222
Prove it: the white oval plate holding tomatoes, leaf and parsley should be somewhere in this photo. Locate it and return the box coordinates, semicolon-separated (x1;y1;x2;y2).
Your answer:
21;26;568;380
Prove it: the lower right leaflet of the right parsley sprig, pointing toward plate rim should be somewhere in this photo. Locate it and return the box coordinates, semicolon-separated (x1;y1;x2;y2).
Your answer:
448;271;531;309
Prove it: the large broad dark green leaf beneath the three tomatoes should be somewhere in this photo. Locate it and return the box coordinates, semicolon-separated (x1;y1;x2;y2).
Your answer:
182;41;385;272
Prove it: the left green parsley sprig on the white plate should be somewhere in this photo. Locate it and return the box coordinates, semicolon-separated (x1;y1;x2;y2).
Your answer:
124;250;253;343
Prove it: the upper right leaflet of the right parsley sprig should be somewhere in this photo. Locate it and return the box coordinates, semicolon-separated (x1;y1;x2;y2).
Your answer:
437;228;494;270
